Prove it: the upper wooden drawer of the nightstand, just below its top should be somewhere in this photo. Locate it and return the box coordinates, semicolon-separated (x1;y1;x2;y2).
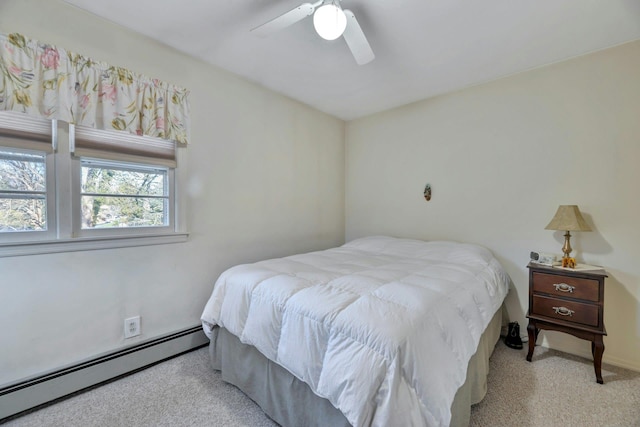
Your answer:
533;271;600;302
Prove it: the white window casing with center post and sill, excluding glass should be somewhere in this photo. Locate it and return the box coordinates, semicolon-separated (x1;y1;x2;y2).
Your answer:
0;117;189;257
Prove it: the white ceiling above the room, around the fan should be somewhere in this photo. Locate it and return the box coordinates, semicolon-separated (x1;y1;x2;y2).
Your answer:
65;0;640;120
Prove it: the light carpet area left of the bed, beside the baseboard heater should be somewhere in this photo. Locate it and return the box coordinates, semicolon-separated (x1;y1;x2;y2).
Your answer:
3;347;276;427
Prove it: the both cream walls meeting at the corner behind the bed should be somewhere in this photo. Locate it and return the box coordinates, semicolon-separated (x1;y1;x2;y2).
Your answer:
0;0;640;392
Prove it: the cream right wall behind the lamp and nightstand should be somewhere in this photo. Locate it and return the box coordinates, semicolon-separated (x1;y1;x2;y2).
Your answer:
346;42;640;370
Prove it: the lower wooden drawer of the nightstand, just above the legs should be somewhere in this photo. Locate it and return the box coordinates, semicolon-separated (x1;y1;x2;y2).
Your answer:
531;295;599;327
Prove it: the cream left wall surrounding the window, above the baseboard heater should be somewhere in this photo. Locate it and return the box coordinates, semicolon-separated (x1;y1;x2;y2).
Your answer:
0;0;344;385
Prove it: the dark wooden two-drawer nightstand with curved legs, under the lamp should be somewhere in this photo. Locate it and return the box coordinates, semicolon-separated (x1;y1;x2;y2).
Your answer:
527;262;607;384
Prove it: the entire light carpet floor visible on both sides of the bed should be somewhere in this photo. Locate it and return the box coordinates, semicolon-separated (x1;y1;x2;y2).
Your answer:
6;342;640;427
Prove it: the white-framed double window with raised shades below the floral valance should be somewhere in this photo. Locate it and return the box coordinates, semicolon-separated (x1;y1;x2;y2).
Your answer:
0;112;186;256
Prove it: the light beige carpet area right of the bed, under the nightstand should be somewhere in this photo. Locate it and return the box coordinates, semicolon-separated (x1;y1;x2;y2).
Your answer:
471;342;640;427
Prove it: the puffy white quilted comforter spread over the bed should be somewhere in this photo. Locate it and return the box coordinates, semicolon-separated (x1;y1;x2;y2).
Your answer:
202;237;509;426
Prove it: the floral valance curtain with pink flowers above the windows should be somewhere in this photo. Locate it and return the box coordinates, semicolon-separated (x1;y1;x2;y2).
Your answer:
0;33;190;144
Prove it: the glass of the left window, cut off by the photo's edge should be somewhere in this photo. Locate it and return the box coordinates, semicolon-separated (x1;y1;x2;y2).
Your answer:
0;150;47;233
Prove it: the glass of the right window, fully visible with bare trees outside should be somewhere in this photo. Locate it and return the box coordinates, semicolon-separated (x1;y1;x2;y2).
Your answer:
80;161;169;229
